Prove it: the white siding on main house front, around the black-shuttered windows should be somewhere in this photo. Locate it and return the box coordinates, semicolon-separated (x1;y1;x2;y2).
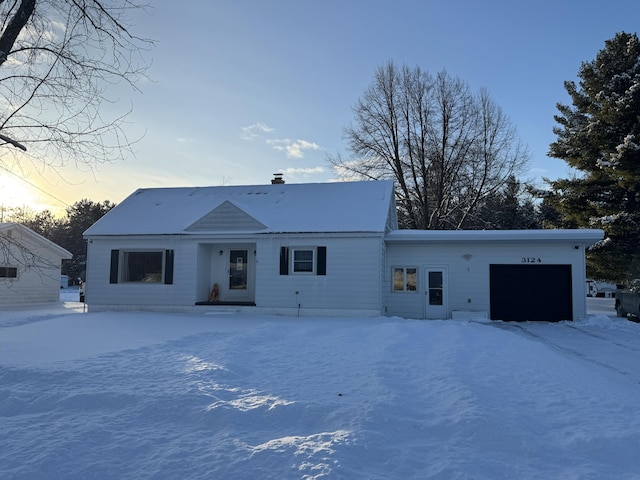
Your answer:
86;235;383;316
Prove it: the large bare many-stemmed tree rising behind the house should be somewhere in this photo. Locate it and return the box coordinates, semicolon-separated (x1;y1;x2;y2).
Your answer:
329;62;529;229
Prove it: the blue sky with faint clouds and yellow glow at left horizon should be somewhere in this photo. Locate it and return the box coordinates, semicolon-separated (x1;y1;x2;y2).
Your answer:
0;0;640;213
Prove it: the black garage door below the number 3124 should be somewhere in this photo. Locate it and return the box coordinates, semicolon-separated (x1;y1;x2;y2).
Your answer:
489;265;573;322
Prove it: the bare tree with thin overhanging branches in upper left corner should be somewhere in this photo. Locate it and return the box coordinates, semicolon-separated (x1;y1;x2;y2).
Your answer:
0;0;152;169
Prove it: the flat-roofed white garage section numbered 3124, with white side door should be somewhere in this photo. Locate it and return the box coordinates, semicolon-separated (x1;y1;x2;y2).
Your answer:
383;229;603;322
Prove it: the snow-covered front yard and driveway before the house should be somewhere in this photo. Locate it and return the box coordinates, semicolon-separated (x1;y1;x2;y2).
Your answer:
0;290;640;480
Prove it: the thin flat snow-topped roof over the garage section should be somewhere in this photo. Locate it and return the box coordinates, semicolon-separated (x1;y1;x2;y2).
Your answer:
385;229;604;244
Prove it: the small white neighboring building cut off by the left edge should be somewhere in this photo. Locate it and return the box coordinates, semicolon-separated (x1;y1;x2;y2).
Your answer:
0;223;72;305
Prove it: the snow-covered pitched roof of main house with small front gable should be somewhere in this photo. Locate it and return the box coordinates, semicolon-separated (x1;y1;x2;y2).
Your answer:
84;180;395;237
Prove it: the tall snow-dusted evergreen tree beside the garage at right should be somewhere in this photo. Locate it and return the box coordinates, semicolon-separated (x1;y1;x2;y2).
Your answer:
544;32;640;281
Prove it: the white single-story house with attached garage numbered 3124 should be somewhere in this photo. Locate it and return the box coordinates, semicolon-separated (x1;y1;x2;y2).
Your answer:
85;181;603;320
